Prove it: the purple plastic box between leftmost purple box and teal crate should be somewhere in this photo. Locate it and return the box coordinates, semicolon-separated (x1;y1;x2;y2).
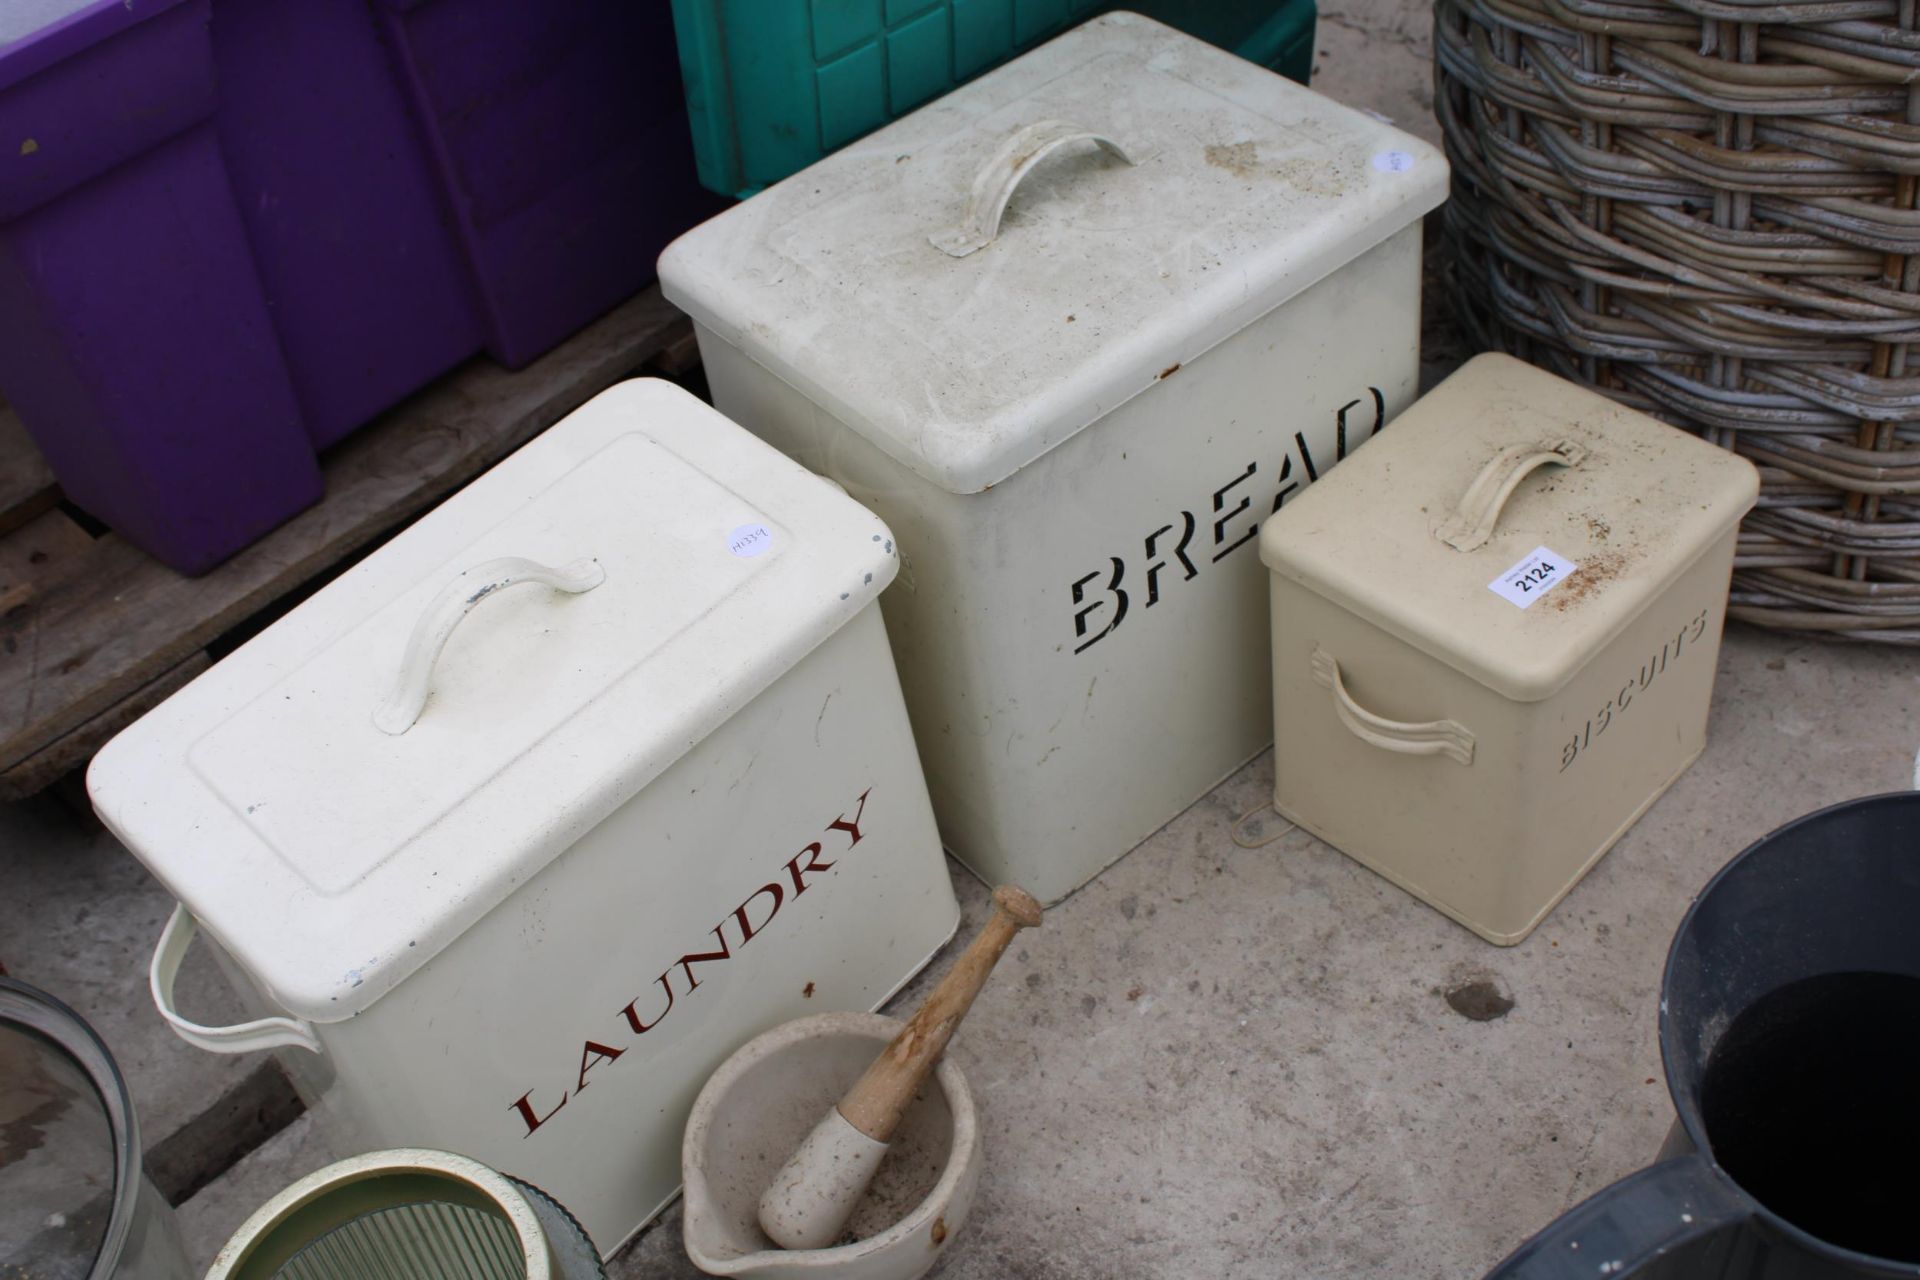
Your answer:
213;0;726;437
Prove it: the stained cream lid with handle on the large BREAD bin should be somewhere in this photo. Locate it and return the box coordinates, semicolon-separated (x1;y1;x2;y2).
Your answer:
660;13;1448;493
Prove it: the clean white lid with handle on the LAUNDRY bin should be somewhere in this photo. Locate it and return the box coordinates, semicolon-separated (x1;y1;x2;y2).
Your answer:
88;380;897;1021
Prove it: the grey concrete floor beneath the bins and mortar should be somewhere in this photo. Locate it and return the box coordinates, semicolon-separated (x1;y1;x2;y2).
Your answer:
15;0;1920;1280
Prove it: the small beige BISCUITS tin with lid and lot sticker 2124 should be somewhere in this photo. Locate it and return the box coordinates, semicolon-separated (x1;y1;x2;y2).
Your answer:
1260;355;1759;946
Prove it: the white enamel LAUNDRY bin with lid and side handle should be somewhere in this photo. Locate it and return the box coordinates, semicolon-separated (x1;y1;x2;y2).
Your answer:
88;382;958;1251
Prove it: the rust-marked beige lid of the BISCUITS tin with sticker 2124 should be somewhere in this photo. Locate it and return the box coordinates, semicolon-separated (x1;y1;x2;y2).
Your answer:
1260;353;1759;702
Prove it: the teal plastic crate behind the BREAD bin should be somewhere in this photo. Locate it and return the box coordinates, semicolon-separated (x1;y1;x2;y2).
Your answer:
674;0;1315;198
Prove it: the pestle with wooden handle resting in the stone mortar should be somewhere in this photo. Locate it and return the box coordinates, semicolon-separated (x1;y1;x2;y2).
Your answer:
760;885;1041;1249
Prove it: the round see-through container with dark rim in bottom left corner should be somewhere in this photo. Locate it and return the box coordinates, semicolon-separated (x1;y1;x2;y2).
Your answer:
0;977;192;1280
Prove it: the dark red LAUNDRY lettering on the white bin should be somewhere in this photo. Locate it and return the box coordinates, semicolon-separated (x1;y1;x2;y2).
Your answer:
507;787;874;1138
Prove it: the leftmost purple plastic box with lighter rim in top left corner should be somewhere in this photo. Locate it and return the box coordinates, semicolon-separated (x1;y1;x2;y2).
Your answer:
0;0;321;574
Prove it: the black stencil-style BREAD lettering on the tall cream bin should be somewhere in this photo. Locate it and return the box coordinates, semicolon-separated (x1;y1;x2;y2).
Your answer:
1068;388;1386;652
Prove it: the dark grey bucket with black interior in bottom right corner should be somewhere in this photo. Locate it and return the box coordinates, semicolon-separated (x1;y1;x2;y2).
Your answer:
1488;793;1920;1280
